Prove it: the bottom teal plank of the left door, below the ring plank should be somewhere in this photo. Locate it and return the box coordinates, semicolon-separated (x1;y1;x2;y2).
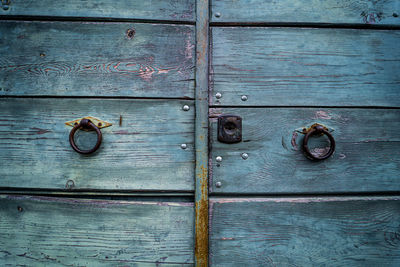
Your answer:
0;196;194;266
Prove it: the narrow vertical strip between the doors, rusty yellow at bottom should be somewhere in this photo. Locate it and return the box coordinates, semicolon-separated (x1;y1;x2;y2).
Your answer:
195;0;209;266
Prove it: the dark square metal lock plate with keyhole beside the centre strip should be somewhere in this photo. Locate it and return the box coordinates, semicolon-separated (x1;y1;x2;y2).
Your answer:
218;115;242;144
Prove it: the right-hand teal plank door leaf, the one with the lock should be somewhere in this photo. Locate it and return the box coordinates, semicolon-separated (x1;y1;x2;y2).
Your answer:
209;0;400;266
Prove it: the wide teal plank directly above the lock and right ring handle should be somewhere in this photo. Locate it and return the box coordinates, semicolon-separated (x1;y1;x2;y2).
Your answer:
211;27;400;106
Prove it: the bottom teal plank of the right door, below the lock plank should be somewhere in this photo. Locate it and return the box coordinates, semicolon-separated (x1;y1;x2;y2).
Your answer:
210;197;400;267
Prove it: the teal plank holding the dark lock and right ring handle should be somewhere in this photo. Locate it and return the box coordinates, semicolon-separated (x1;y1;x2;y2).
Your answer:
210;108;400;194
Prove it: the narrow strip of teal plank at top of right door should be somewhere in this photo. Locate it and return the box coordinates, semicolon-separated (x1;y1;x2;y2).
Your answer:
211;0;400;25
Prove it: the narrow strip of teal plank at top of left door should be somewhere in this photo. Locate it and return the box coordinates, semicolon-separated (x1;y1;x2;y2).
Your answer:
0;0;195;21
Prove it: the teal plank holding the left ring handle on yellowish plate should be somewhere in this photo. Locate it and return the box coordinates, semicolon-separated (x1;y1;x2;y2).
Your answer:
0;98;194;191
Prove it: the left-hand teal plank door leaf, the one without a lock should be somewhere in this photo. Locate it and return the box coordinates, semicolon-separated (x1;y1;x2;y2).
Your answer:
0;0;196;266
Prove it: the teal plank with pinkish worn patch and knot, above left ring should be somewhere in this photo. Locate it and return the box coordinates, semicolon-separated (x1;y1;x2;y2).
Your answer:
0;21;195;98
